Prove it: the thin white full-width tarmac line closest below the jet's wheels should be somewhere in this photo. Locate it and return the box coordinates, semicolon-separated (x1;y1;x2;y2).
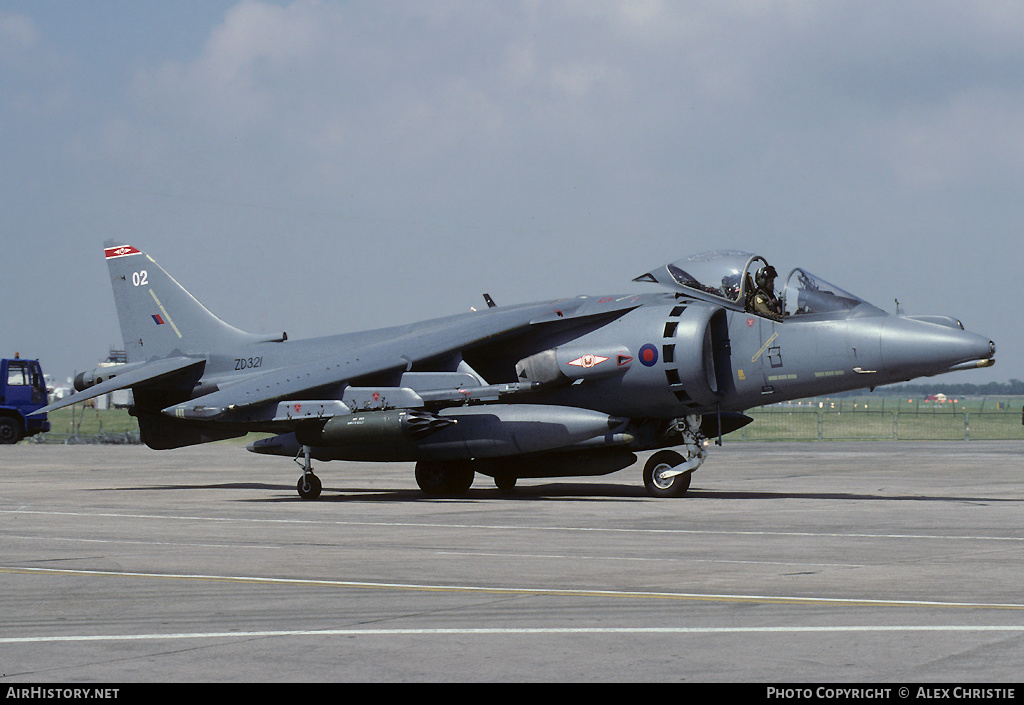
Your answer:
0;509;1024;543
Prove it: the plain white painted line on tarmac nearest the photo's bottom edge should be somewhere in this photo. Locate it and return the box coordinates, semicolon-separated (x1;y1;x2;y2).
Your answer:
0;624;1024;645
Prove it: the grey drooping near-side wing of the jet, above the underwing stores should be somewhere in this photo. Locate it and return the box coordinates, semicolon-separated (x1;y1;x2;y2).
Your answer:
163;299;637;421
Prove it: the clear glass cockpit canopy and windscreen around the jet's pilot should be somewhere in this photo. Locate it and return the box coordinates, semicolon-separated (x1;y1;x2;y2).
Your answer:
633;250;880;318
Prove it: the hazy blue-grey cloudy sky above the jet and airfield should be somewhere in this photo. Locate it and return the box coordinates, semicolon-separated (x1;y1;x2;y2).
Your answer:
0;0;1024;391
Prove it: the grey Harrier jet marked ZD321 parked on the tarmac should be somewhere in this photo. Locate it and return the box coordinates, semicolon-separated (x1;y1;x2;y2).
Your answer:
32;242;995;499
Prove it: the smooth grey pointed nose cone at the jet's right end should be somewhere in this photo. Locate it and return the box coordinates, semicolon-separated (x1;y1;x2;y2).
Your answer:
881;317;995;379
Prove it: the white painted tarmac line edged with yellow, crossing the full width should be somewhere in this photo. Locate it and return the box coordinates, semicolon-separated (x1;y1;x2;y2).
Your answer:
6;566;1024;610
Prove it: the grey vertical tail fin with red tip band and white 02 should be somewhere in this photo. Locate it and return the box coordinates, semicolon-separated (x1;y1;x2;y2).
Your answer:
103;241;269;362
